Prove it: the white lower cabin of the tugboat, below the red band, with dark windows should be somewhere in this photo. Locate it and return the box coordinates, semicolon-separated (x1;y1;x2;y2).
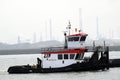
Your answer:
41;50;84;68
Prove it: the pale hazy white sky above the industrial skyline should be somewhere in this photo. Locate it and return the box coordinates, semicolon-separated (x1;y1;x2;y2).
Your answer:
0;0;120;43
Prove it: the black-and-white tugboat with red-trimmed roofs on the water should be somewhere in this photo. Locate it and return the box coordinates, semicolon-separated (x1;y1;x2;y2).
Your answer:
8;22;109;73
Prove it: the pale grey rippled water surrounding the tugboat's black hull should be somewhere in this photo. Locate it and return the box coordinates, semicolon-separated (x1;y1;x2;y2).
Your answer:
0;51;120;80
